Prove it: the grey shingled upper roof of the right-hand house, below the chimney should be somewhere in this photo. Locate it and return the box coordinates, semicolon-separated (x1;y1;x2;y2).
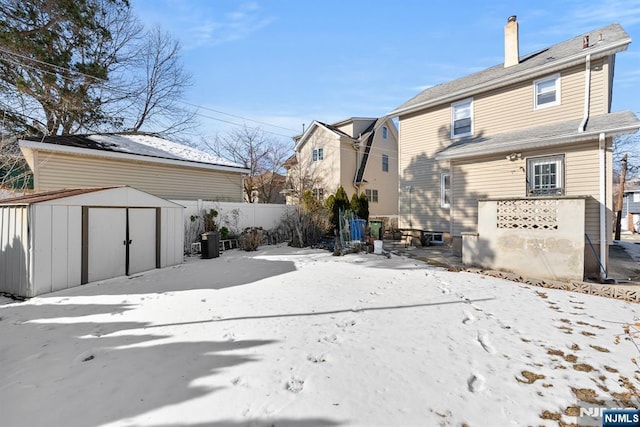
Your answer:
389;24;631;116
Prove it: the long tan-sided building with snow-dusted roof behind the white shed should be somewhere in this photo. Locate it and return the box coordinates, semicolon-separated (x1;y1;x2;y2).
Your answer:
19;134;248;202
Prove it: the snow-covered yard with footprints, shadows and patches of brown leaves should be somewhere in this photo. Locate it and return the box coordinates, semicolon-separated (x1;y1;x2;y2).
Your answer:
0;246;640;427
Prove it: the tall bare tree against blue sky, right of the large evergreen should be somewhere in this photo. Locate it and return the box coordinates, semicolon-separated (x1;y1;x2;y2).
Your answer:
126;27;195;135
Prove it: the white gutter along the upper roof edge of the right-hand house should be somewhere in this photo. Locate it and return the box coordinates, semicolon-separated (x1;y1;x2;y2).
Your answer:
387;37;631;117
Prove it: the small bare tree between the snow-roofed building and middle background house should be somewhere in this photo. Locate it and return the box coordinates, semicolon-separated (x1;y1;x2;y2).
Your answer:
204;126;290;203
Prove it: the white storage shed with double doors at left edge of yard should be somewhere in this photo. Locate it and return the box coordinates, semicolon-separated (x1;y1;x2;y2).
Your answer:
0;187;184;297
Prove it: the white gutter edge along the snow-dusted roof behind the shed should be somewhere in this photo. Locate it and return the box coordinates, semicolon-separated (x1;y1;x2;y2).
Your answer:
19;140;250;173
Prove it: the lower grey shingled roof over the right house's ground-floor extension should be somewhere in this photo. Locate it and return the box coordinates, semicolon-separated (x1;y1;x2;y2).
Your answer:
435;111;640;160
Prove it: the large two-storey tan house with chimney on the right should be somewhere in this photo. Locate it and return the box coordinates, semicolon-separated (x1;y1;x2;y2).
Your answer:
389;16;640;278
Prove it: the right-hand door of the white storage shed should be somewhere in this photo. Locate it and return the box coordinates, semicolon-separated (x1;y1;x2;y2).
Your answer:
129;208;156;274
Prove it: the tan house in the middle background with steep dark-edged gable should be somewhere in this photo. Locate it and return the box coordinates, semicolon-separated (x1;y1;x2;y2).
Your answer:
285;117;398;216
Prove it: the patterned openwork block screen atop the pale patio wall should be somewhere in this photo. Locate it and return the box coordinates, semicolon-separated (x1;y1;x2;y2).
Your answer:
498;199;558;230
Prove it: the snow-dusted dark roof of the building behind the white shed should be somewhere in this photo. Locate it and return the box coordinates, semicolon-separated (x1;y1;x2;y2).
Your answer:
20;133;246;172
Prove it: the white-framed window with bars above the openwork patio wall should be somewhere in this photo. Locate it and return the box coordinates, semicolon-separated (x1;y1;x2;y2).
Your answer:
527;155;564;196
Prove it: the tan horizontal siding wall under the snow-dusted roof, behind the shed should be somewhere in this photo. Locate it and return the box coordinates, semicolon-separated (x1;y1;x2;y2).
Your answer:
35;152;242;202
